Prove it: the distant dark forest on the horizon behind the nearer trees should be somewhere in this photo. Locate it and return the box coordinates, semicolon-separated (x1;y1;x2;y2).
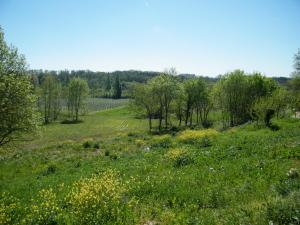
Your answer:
29;70;290;98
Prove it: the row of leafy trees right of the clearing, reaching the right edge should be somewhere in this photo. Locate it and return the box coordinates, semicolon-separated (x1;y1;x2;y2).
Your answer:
132;64;300;131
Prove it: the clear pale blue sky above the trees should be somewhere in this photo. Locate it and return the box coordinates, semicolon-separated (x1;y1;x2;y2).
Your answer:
0;0;300;76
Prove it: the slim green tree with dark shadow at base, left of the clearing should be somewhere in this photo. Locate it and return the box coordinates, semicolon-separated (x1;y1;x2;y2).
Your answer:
67;78;89;121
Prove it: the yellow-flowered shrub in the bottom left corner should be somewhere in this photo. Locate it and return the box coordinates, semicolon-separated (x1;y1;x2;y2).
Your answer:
0;192;20;225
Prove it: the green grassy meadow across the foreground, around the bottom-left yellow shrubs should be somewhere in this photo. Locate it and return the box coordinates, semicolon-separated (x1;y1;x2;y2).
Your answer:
0;107;300;224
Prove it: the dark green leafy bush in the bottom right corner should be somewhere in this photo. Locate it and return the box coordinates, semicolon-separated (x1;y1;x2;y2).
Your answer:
267;191;300;224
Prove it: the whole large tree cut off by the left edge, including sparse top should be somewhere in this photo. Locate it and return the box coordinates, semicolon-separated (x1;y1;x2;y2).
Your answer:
0;28;38;146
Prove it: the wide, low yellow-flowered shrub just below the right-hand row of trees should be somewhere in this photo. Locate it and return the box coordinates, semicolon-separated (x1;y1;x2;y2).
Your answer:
177;129;218;147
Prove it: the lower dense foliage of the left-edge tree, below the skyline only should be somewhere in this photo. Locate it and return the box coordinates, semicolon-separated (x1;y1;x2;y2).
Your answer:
0;74;39;145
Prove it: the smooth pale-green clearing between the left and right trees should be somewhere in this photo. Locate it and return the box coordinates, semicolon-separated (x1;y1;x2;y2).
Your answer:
21;106;147;149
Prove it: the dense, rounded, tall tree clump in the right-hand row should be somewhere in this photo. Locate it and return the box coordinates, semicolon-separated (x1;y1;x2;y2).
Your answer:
214;70;277;126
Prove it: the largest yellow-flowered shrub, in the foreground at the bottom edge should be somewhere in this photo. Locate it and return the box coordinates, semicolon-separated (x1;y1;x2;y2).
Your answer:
66;170;133;224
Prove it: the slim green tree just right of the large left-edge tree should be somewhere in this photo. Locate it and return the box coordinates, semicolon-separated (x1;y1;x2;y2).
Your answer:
40;75;61;124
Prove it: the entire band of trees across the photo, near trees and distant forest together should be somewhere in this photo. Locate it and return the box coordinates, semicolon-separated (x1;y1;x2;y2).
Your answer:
0;27;300;146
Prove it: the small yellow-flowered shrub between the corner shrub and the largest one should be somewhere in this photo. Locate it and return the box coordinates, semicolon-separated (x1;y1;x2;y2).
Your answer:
25;188;62;225
